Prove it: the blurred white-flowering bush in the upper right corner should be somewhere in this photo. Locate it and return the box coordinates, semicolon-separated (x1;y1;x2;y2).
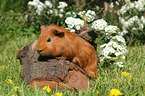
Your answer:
111;0;145;44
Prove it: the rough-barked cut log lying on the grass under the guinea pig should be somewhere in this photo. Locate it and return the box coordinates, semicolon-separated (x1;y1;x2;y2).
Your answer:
17;41;89;90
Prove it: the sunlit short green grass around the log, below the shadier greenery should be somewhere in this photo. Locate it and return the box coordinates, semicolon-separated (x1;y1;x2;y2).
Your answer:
0;31;145;96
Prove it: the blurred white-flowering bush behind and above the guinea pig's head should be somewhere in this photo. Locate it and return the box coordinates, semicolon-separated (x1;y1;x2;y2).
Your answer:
27;0;67;28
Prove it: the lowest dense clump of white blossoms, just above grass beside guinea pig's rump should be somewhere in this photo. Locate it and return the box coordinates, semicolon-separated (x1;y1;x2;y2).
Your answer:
100;36;127;67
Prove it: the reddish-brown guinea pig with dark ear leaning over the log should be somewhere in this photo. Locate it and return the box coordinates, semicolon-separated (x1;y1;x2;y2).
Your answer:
36;25;98;78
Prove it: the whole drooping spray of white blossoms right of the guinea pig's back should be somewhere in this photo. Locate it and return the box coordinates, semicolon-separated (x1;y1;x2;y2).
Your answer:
92;19;127;67
